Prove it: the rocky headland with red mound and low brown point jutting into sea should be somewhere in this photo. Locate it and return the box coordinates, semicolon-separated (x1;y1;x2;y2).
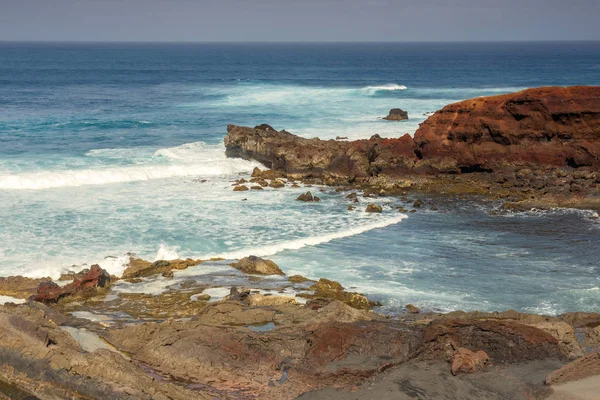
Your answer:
225;87;600;210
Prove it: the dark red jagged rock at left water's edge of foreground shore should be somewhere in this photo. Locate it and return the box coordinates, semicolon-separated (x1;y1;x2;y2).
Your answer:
30;265;110;303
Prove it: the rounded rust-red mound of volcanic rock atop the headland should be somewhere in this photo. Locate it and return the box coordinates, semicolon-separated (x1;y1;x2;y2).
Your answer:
415;86;600;172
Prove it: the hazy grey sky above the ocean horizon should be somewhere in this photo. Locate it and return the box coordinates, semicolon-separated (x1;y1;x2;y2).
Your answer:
0;0;600;42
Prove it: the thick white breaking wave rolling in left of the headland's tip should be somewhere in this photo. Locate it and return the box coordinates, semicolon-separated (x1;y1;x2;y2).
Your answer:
0;142;257;190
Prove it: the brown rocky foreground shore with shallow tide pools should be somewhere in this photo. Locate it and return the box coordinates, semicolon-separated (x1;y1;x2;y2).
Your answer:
0;257;600;400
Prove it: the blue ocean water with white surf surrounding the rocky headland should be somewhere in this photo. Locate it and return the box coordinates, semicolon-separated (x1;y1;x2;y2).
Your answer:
0;42;600;313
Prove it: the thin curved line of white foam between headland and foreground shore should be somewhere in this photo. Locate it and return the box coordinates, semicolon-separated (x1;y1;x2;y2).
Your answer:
201;215;407;259
